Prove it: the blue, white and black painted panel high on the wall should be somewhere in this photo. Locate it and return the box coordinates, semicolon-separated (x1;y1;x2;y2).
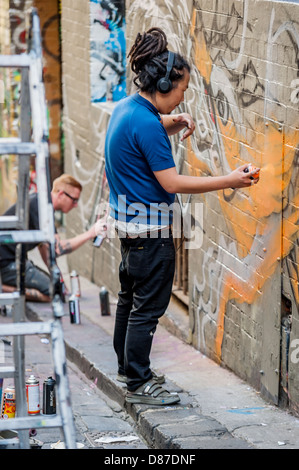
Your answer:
90;0;126;103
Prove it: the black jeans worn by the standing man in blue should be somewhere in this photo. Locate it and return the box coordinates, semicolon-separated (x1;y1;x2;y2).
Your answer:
114;231;175;391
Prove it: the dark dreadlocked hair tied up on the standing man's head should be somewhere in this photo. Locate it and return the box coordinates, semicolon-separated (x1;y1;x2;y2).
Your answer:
128;28;190;94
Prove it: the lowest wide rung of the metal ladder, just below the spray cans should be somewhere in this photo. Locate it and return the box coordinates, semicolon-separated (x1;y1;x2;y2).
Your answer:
0;414;62;432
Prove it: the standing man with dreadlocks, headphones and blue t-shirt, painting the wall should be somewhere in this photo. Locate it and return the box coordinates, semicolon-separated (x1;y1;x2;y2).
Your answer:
105;28;258;405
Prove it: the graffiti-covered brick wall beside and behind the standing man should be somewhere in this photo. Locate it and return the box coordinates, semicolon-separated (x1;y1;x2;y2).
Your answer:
62;0;299;410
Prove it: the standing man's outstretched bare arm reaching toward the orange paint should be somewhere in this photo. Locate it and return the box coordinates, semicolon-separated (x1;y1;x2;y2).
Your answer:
154;164;259;194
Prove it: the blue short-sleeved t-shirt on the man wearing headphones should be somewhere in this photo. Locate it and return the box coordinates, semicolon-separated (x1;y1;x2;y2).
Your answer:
105;94;175;225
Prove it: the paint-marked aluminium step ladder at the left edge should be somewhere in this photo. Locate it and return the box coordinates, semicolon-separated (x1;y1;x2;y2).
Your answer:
0;9;76;449
